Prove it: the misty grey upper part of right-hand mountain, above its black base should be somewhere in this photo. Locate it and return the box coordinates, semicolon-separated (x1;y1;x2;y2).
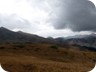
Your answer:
66;34;96;46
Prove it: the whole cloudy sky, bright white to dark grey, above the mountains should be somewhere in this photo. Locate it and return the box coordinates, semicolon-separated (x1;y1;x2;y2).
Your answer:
0;0;96;37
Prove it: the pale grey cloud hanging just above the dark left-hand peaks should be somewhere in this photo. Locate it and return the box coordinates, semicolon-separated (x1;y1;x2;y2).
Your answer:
0;14;30;29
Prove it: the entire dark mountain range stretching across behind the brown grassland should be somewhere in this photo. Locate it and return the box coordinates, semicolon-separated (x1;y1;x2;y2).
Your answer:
0;27;96;51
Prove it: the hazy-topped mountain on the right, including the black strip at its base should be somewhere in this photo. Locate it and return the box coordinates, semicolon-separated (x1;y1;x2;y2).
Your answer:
65;34;96;51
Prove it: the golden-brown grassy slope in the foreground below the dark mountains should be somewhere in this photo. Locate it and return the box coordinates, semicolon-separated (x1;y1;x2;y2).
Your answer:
0;44;96;72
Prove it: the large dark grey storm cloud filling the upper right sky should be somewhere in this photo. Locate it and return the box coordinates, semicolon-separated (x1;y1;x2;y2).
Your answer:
51;0;96;31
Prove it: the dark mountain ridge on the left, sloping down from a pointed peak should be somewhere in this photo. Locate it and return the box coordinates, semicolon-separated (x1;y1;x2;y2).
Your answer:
0;27;53;43
